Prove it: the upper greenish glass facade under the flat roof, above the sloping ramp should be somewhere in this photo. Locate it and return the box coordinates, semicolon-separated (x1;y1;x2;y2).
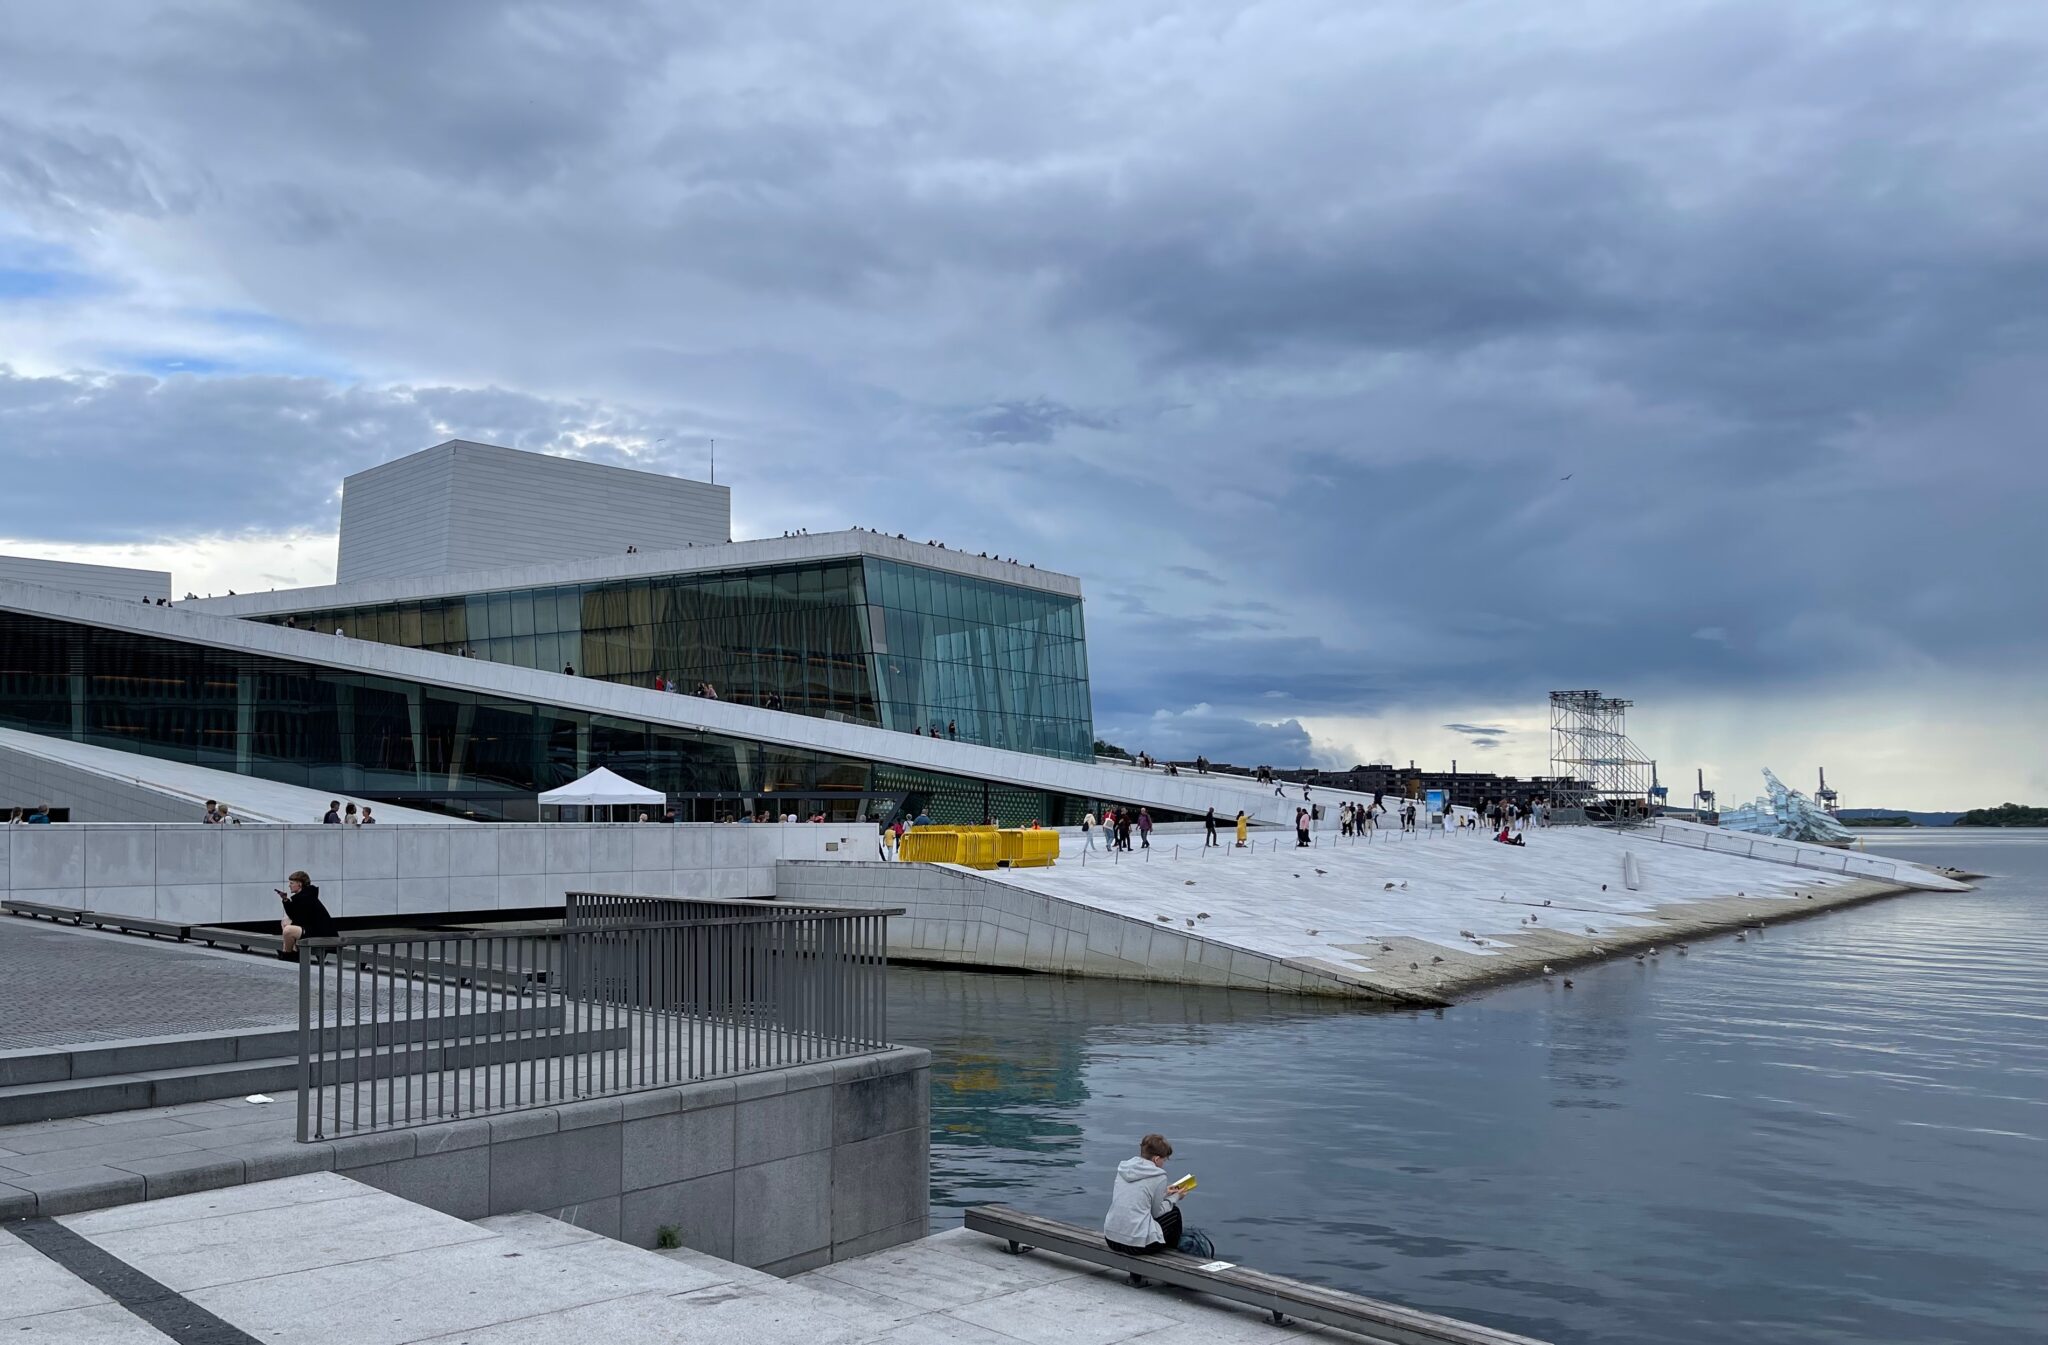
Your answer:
264;557;1096;762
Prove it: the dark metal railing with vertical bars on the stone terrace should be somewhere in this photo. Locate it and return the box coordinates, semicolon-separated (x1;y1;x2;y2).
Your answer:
299;901;901;1140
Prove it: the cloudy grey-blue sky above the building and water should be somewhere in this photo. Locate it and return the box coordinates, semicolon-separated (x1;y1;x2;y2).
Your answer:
0;0;2048;807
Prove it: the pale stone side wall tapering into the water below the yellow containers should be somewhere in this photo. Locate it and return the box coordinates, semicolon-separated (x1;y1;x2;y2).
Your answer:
776;860;1380;997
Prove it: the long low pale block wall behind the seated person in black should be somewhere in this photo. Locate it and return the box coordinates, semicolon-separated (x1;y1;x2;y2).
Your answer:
0;823;870;923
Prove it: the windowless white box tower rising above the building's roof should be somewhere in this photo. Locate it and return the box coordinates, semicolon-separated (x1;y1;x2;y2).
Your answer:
336;440;733;583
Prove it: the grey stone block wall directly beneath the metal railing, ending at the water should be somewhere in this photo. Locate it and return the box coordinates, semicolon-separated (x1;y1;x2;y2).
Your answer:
339;1048;932;1275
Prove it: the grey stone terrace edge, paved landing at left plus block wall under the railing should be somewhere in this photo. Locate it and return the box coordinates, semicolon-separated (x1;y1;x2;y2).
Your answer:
0;1048;932;1273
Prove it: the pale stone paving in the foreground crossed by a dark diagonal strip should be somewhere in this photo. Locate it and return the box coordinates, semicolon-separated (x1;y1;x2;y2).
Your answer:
0;1173;1392;1345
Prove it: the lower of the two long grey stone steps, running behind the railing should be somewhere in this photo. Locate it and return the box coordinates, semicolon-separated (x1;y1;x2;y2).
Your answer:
0;1028;631;1126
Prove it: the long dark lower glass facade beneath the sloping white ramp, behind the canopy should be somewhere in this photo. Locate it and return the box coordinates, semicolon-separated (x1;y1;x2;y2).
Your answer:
0;612;1114;825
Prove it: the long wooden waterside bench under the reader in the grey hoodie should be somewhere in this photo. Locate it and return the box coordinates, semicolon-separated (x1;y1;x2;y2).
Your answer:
967;1206;1544;1345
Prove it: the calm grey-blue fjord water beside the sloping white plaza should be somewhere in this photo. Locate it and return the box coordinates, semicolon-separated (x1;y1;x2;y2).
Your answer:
891;831;2048;1345
